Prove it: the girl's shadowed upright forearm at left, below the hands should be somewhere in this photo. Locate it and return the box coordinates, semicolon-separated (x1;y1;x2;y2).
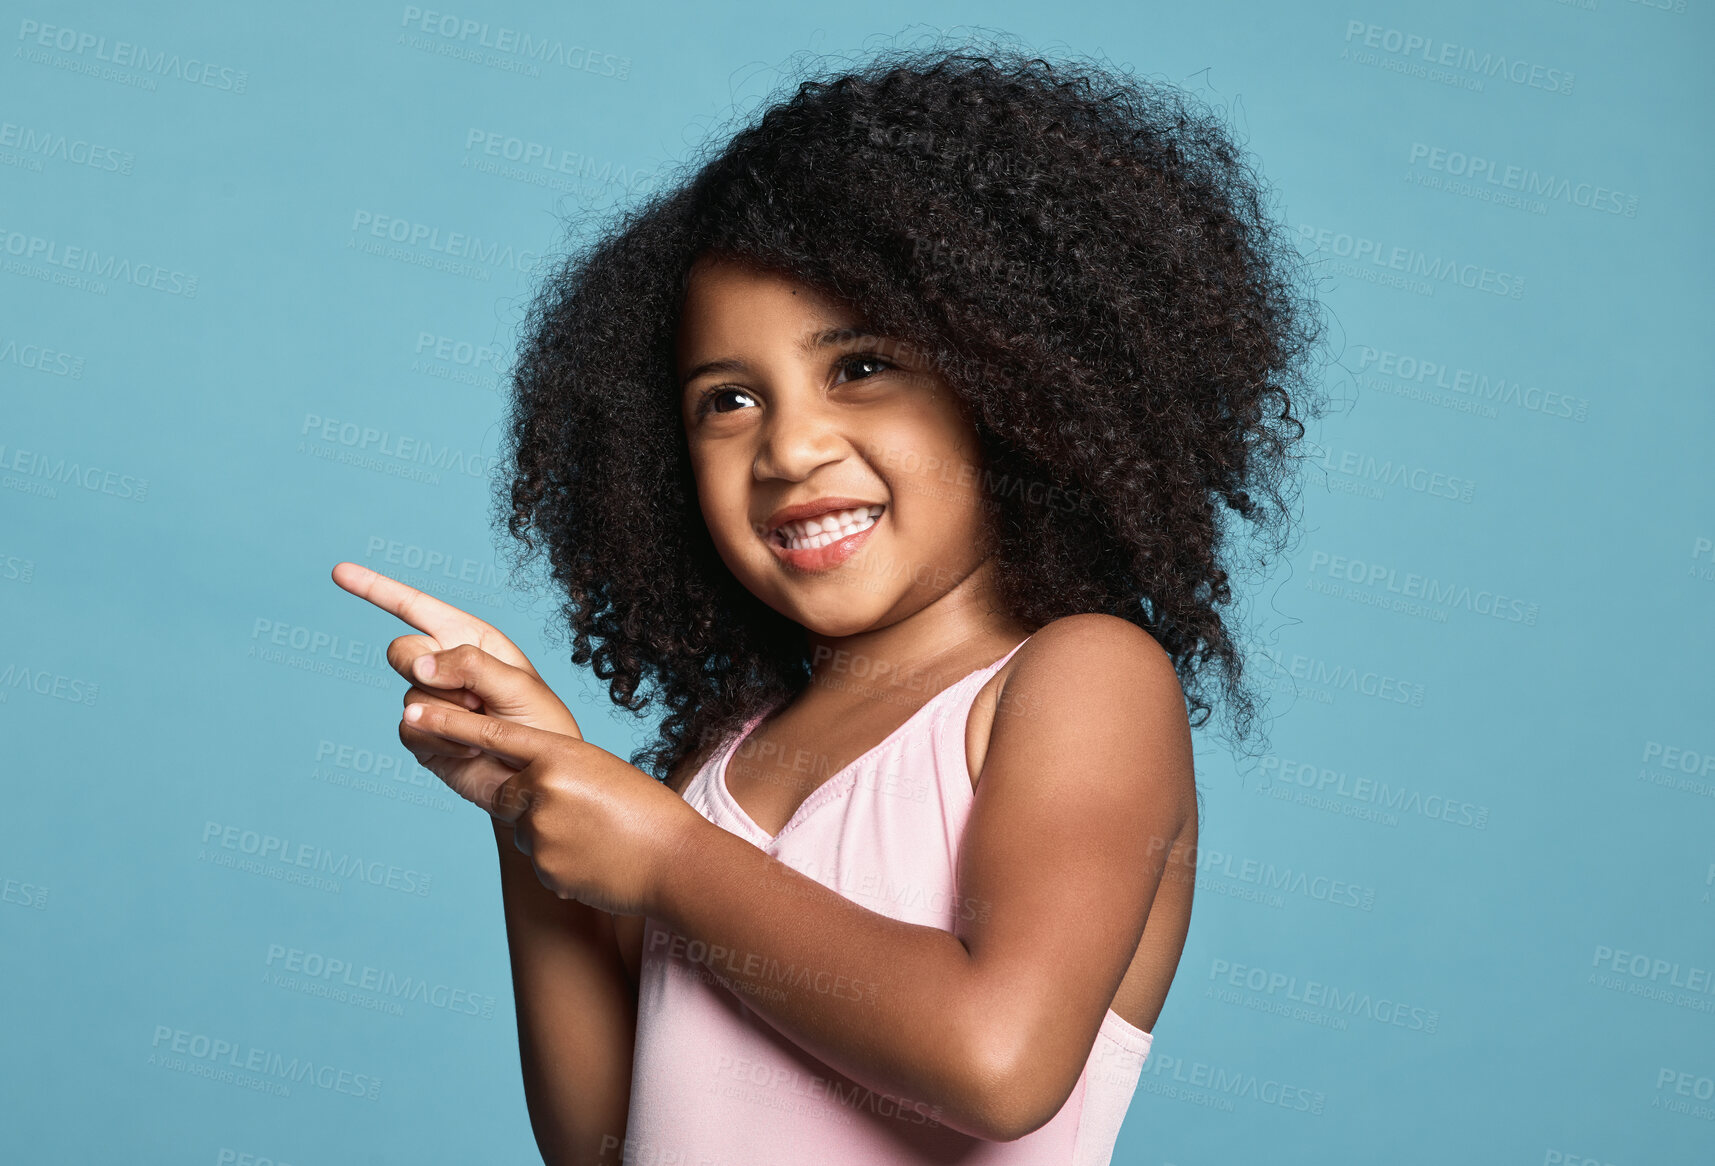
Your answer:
494;821;636;1166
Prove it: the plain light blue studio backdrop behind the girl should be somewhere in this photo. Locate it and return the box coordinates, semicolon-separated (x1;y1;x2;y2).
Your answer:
0;0;1715;1166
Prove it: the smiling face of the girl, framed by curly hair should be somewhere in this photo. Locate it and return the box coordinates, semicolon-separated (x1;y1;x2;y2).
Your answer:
677;259;990;638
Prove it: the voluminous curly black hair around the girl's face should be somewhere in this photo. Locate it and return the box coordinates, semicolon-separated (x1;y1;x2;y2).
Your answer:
499;46;1322;778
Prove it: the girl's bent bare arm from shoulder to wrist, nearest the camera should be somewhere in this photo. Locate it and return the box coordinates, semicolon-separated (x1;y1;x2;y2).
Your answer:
648;616;1195;1140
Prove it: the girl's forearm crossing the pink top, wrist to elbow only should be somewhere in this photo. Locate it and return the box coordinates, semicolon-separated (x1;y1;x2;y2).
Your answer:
650;823;1000;1137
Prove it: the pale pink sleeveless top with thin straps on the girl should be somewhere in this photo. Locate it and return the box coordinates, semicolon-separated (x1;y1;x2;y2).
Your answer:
624;643;1152;1166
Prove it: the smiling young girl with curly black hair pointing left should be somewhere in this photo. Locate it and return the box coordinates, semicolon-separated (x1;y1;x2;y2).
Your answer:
334;40;1317;1166
